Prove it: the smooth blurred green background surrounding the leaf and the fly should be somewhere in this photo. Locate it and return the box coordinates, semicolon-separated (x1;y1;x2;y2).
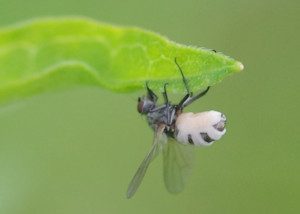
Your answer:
0;0;300;214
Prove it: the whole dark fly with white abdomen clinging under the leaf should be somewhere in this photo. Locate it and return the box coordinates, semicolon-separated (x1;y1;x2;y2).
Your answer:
127;58;226;198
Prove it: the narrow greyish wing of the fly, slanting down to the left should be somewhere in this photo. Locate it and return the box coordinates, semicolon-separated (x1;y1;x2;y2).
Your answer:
127;125;166;198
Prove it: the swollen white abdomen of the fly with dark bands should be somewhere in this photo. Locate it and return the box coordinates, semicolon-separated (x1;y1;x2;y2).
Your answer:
175;111;226;146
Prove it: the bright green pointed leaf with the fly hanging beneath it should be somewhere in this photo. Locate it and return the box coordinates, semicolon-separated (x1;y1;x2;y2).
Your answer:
0;17;243;102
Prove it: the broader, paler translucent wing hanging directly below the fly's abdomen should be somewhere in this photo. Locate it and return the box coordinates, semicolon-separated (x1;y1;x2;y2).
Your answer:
163;138;194;193
